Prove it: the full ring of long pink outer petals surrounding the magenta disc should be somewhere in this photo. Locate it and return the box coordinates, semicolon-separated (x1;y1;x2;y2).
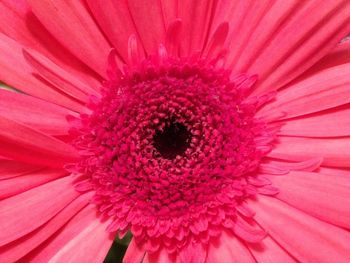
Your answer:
0;0;350;263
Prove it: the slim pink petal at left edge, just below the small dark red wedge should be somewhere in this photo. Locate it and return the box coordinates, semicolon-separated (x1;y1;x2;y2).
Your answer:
0;169;67;200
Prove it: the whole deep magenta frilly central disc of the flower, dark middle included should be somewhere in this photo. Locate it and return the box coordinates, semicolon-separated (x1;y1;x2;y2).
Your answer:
69;53;274;254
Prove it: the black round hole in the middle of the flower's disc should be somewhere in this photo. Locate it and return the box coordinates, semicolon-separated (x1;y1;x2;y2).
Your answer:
153;121;191;159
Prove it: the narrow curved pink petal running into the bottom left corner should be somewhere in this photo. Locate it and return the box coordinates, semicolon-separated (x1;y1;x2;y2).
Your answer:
0;193;91;262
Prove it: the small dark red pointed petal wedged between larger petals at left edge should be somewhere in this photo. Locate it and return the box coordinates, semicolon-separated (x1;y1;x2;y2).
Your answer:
0;159;42;180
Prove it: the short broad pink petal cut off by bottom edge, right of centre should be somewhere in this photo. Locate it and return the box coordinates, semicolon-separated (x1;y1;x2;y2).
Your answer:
207;231;255;263
